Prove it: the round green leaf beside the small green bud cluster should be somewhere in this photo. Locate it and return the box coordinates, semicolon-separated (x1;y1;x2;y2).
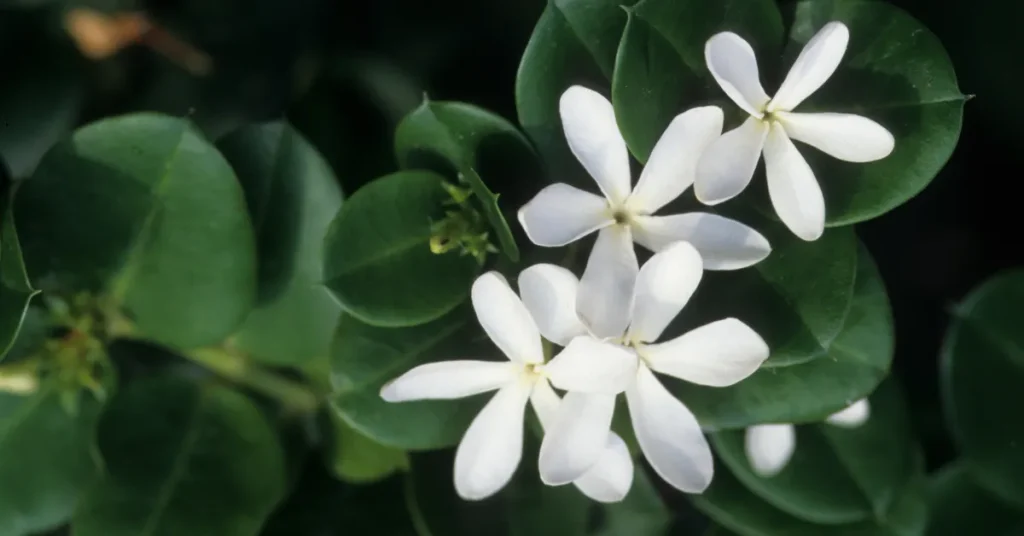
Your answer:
324;171;480;327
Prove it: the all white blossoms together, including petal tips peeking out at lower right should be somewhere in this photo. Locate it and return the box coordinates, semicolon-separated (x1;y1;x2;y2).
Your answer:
381;23;893;502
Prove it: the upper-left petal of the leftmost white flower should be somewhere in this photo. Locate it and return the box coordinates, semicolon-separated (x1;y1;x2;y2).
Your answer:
470;272;544;363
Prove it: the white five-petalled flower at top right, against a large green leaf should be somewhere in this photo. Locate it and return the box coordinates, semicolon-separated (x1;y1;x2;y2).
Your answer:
694;23;895;240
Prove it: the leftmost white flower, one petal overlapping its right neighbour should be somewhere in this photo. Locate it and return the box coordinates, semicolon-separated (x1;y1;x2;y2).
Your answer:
381;272;635;502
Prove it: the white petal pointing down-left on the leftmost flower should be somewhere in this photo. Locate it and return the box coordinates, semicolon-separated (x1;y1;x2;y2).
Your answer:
455;381;530;500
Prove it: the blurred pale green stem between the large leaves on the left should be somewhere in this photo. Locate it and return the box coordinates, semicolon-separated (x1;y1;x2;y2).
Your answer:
182;347;319;413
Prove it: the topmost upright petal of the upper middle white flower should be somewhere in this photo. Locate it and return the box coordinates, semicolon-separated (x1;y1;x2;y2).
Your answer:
558;86;632;205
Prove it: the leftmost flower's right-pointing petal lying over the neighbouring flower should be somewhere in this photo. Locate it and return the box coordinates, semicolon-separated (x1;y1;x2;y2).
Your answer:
544;335;637;395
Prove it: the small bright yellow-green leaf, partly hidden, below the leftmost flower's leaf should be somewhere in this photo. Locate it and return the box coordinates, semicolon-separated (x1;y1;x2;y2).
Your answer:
328;412;409;484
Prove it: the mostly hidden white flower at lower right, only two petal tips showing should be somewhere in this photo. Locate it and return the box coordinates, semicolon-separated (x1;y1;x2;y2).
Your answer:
743;399;870;478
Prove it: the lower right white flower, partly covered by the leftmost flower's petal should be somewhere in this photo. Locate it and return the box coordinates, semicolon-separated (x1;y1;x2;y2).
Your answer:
520;242;768;493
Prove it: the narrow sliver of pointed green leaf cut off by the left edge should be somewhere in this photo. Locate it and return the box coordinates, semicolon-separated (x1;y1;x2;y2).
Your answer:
0;187;39;361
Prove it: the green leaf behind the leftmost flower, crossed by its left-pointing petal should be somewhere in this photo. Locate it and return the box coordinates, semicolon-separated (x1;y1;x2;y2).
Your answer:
331;306;487;450
